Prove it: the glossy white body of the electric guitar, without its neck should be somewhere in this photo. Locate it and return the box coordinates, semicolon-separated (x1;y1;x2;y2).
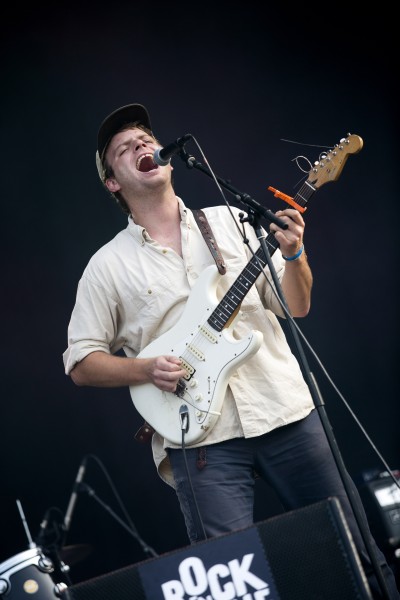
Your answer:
130;265;262;445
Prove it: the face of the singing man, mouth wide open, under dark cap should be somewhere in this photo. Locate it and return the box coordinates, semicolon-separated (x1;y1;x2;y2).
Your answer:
105;128;171;200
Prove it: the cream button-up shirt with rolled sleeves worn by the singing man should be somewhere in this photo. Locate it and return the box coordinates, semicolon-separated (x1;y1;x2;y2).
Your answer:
63;198;314;486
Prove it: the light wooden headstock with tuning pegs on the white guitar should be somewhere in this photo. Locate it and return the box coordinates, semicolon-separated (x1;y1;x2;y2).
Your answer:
307;134;364;189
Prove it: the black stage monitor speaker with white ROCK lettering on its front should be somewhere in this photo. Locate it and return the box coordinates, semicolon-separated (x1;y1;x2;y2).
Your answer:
61;498;372;600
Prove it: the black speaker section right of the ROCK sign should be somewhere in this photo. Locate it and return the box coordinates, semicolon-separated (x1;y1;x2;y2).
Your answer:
257;499;371;600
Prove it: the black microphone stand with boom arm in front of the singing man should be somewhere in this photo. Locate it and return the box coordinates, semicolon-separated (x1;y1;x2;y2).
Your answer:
179;148;390;600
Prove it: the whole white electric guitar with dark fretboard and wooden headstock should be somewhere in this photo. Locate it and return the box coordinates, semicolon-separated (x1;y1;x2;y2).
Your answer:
130;135;363;445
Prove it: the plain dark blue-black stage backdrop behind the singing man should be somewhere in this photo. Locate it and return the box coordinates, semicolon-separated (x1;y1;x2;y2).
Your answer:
0;2;400;583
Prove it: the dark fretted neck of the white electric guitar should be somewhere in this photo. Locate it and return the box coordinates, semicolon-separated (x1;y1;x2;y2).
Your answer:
207;181;315;331
